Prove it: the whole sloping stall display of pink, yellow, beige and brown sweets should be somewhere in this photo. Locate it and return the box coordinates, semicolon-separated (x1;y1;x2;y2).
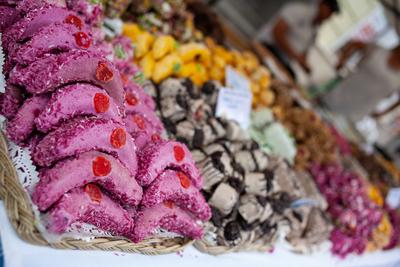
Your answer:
0;0;400;264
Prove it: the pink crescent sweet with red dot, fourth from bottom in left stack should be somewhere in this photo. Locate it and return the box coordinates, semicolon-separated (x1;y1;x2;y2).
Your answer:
35;83;122;132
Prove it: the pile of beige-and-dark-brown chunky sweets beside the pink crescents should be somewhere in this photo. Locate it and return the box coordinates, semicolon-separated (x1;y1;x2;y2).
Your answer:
156;78;330;251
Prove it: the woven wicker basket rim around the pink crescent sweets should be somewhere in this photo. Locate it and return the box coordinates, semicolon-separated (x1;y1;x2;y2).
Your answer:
0;131;193;255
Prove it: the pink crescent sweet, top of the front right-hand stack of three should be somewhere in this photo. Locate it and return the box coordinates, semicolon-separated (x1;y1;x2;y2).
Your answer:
136;141;203;189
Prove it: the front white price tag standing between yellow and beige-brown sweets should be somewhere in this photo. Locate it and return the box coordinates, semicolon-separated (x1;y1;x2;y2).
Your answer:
216;88;252;129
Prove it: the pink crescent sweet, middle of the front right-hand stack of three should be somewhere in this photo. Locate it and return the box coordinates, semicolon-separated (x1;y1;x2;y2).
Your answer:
142;170;211;221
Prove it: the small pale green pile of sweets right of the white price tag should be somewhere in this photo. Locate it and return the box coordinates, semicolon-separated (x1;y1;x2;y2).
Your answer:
249;108;296;164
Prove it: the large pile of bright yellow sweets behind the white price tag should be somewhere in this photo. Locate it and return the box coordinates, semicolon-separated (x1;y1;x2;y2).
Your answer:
123;23;274;95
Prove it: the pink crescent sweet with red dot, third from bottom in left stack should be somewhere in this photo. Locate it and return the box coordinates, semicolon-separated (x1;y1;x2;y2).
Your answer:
32;118;137;176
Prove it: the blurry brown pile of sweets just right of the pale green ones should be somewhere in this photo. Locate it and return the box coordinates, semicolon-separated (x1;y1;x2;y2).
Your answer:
270;81;338;170
